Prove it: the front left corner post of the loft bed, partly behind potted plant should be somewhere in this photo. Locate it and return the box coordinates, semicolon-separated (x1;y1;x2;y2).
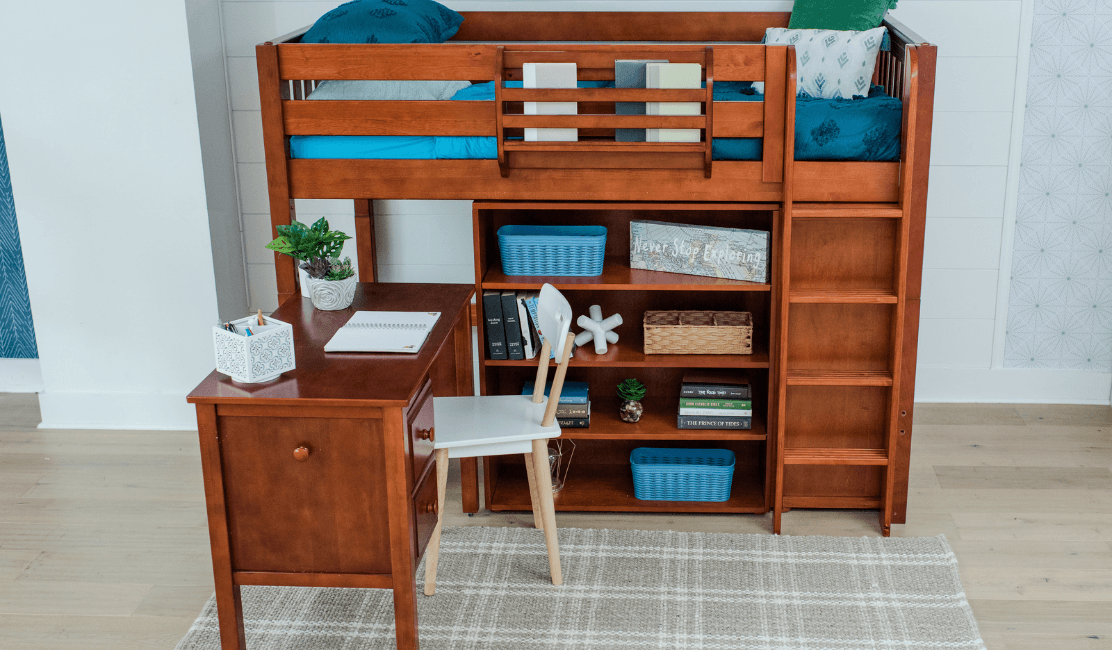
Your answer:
255;41;297;304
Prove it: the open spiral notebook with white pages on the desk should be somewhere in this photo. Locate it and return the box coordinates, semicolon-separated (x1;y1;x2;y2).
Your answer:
325;311;440;354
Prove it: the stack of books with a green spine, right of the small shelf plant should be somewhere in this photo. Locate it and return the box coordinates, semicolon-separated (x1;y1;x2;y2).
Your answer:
676;370;753;429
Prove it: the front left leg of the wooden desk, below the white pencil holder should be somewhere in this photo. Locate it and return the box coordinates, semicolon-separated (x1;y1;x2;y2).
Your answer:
197;404;247;650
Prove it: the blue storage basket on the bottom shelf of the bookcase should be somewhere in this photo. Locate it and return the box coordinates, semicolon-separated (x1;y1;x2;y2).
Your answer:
629;447;734;501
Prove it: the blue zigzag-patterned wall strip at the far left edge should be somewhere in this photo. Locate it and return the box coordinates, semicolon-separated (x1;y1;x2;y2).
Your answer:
0;116;39;359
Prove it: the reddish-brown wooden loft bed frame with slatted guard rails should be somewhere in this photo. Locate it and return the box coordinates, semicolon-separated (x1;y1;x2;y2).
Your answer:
256;12;935;303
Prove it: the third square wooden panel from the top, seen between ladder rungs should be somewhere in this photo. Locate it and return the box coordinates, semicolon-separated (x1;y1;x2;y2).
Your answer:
784;386;888;449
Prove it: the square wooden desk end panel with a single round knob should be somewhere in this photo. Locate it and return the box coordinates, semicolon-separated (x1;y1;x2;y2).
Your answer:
218;416;390;573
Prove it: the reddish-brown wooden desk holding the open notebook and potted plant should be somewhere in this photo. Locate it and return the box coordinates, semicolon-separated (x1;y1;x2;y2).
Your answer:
188;284;474;650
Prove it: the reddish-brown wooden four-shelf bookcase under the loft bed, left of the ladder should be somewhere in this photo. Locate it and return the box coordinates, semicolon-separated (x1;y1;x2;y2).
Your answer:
473;201;782;513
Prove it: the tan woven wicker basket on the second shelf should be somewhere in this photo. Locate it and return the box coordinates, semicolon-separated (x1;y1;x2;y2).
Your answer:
645;311;753;354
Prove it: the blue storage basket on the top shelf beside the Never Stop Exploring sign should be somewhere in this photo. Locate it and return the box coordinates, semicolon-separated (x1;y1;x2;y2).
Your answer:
498;226;606;276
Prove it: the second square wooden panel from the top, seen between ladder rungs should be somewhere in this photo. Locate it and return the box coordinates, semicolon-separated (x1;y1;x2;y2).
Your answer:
787;303;893;371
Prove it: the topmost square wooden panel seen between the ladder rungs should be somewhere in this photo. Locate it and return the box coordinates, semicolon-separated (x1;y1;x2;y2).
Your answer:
791;219;897;291
